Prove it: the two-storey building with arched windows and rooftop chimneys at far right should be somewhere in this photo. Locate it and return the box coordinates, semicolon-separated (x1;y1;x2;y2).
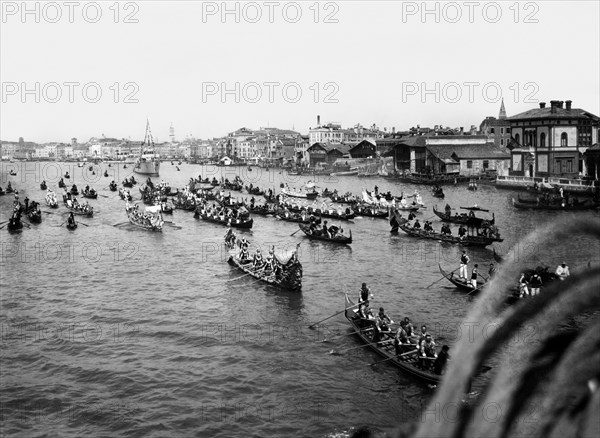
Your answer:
507;100;600;178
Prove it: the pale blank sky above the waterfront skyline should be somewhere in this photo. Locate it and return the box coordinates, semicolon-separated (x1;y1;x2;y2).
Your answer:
0;1;600;142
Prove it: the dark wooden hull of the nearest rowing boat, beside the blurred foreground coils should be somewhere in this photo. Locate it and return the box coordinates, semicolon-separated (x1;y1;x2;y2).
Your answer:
344;294;442;384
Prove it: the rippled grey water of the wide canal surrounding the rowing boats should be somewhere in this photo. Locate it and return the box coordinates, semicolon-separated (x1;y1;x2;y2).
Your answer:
0;162;599;437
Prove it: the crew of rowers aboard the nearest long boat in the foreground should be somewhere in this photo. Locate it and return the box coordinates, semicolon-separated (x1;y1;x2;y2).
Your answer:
357;283;450;375
